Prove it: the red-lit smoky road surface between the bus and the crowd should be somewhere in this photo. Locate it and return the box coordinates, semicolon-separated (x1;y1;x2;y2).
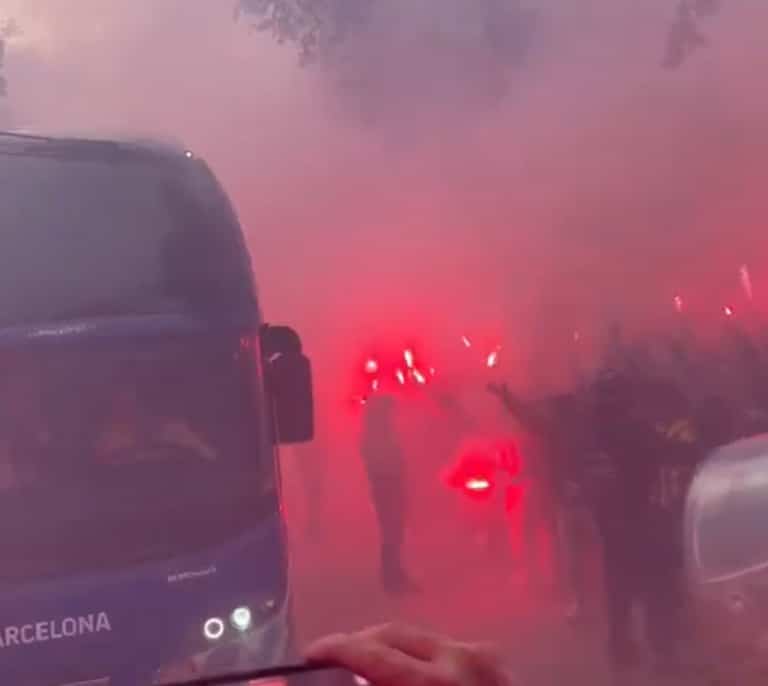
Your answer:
283;448;628;686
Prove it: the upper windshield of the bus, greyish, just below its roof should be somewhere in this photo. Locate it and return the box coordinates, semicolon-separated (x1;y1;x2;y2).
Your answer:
0;150;252;326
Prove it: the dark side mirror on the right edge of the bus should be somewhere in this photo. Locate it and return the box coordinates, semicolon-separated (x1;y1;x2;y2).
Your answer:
261;325;315;444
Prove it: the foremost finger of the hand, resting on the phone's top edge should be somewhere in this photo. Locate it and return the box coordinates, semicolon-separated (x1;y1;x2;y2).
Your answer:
306;632;435;686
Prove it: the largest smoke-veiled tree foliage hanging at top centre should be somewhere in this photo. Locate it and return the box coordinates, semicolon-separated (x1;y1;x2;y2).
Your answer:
238;0;539;117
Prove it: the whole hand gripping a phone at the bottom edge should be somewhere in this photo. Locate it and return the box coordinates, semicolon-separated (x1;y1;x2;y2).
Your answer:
307;624;514;686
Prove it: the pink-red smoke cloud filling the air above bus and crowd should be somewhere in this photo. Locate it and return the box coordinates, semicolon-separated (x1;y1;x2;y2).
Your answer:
0;0;768;398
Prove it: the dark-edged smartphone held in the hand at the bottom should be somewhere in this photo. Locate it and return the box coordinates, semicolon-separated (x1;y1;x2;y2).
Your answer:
167;665;369;686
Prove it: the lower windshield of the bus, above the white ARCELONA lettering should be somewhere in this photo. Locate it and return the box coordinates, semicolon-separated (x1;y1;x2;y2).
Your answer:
0;340;277;586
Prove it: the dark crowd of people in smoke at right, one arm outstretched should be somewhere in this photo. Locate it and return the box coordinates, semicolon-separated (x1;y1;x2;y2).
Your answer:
490;326;768;672
